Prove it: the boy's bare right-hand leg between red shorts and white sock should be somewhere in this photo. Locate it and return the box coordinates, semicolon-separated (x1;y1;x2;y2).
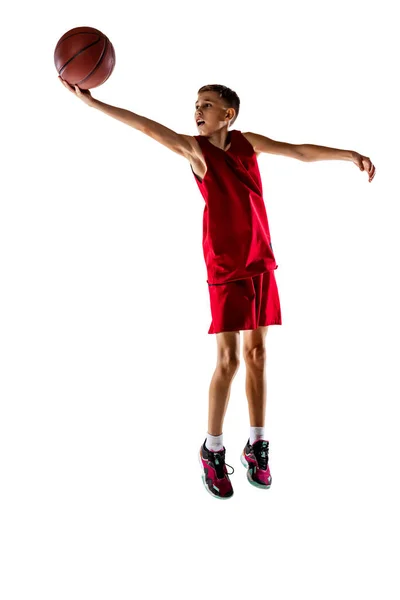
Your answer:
243;327;268;427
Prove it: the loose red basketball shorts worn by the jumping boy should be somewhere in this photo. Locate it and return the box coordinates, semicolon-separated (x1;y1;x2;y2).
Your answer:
208;271;282;333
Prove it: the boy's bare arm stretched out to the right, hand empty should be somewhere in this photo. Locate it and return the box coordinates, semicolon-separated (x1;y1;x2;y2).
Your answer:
243;133;376;183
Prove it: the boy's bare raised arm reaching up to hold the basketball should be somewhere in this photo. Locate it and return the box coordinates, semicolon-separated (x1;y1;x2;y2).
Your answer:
59;77;197;160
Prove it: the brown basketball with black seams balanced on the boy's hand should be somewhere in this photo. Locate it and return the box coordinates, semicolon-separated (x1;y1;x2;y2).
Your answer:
54;27;115;90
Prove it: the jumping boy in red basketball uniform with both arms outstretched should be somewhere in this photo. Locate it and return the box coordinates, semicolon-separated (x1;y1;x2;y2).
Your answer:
59;77;375;499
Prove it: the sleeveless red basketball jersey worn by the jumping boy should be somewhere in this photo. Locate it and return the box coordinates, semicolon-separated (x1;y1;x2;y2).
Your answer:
192;130;278;285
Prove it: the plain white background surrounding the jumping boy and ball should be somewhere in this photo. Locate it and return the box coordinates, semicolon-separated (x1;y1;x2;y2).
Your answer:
0;0;400;600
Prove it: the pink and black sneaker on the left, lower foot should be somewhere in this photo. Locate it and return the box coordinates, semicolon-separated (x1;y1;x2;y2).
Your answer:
199;440;234;500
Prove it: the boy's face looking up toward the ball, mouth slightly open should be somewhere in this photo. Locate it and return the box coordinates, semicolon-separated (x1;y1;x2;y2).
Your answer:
194;92;235;135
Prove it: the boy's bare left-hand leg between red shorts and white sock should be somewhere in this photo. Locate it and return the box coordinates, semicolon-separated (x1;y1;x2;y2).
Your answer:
208;331;240;436
